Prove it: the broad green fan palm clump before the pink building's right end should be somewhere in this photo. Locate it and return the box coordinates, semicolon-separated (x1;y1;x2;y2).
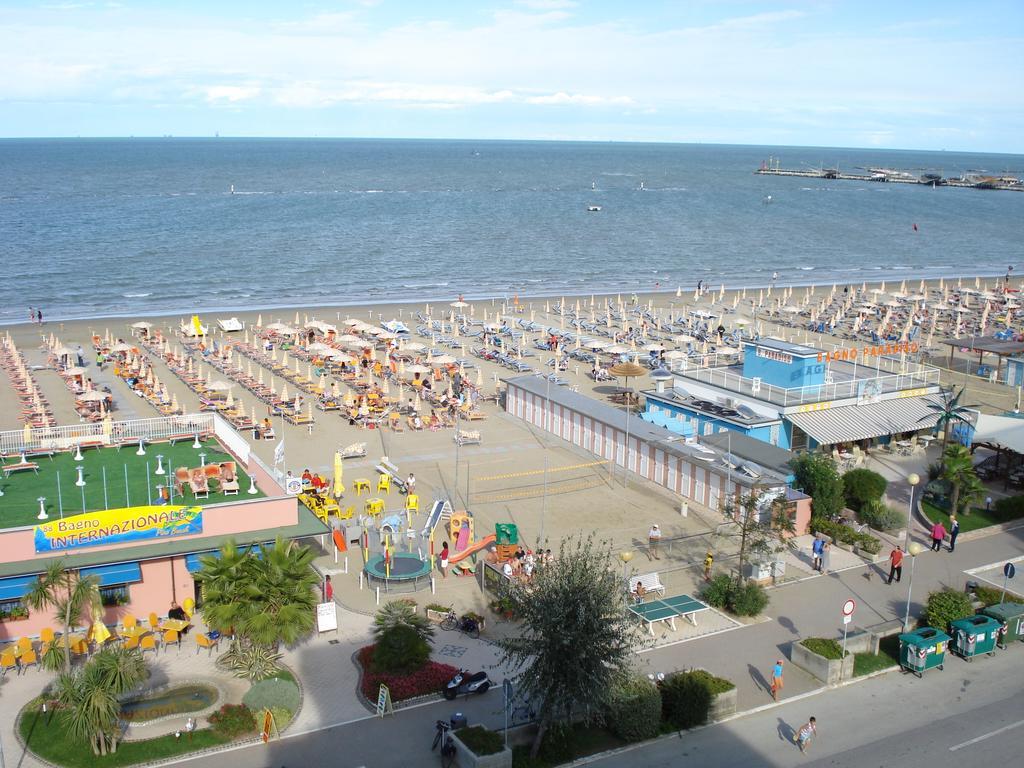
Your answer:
196;537;319;649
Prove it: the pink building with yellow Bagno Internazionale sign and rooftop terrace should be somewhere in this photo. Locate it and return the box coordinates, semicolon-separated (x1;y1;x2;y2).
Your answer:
0;414;328;642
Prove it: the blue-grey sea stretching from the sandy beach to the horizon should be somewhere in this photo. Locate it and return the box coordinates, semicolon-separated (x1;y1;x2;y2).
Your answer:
0;138;1024;323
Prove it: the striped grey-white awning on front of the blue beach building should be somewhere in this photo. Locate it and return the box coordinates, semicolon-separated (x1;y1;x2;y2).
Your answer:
784;397;939;445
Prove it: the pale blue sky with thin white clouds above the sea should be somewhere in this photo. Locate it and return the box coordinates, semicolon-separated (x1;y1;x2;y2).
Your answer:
0;0;1024;154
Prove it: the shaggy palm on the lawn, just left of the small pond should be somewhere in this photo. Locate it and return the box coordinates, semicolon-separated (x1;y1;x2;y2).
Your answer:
54;647;148;755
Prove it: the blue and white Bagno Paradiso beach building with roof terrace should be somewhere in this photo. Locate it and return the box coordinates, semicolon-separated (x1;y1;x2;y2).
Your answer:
643;338;940;451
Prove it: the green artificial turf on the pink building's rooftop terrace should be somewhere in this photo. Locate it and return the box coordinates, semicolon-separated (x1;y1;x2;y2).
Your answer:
0;439;264;528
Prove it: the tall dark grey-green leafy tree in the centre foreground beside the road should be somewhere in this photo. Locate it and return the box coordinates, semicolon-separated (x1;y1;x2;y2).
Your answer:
498;538;639;756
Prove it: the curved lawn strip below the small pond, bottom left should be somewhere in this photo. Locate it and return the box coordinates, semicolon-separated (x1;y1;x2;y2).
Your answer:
18;699;228;768
